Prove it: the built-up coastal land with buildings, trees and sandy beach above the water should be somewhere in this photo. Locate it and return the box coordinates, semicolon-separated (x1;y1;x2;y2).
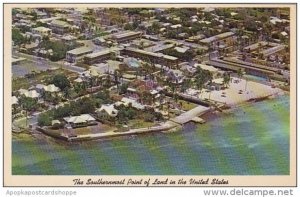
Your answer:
11;7;290;141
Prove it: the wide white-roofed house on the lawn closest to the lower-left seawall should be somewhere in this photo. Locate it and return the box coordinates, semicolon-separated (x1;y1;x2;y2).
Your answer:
63;114;97;128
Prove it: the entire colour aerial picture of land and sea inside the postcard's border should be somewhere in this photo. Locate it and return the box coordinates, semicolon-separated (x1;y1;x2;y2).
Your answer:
10;7;293;175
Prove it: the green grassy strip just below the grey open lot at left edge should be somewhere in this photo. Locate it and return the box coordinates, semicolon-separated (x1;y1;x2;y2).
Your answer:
12;69;77;91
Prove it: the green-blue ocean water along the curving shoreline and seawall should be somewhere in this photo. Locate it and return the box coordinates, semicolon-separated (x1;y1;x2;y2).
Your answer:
12;95;290;175
